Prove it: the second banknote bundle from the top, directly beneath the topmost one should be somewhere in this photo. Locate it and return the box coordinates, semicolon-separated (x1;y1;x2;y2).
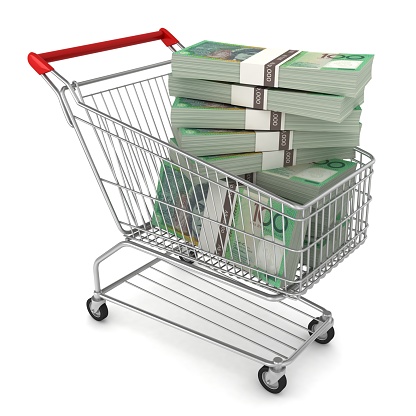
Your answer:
169;75;364;123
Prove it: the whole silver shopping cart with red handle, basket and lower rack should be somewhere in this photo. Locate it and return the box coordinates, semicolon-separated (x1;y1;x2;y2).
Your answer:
28;29;374;393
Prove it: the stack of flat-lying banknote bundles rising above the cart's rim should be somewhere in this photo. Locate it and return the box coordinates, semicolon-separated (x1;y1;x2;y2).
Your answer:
169;41;373;173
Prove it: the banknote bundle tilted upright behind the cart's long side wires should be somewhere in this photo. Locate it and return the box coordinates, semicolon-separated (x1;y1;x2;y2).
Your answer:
151;161;305;287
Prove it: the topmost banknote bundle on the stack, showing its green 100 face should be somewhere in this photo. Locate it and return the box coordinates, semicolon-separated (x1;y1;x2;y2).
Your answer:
172;40;374;97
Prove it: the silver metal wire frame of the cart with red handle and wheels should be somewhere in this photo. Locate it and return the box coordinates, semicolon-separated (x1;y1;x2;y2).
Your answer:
28;29;375;393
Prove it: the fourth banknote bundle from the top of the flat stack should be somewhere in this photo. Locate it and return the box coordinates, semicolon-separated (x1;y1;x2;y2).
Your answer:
174;127;360;158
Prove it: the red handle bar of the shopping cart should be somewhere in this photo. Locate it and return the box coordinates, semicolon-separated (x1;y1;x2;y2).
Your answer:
27;28;179;75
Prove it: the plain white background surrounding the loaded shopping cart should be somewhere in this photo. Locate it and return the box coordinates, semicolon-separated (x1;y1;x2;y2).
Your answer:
0;0;416;415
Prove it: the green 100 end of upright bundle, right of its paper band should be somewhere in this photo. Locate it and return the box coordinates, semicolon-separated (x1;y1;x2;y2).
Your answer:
225;188;305;287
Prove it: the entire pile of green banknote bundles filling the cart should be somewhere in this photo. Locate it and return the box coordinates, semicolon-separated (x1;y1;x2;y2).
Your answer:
152;41;373;288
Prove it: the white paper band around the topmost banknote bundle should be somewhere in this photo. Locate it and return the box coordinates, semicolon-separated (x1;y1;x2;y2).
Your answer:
240;48;301;88
